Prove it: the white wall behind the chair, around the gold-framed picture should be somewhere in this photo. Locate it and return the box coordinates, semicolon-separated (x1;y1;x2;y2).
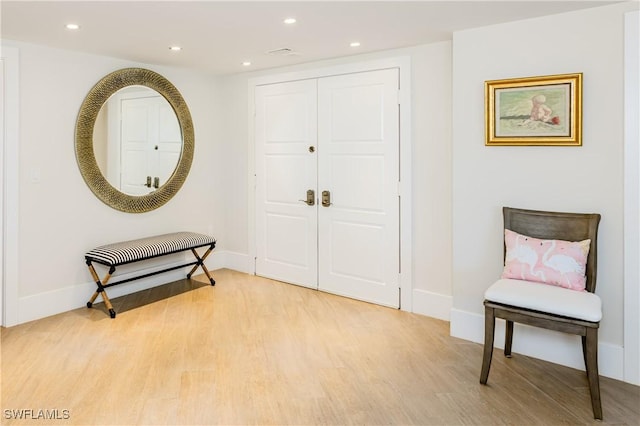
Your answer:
451;2;638;378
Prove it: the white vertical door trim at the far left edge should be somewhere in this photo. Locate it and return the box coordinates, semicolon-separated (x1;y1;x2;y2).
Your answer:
0;46;20;327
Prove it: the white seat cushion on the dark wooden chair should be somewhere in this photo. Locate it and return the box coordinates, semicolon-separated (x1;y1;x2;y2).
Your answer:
484;279;602;322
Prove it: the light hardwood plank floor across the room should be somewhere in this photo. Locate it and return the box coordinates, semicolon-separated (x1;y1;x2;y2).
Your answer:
0;270;640;425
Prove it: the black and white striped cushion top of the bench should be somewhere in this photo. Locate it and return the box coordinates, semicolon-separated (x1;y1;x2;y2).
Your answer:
85;232;216;266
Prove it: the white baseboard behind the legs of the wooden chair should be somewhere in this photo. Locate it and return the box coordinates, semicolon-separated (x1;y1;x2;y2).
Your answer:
450;309;624;380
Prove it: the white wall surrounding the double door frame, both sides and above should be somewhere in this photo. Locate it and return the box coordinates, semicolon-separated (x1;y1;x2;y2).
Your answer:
220;42;452;319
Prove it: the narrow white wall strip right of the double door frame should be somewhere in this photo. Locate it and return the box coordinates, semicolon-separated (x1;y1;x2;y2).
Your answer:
411;42;453;320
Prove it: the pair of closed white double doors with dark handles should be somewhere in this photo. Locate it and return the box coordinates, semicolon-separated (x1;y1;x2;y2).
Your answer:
255;69;400;307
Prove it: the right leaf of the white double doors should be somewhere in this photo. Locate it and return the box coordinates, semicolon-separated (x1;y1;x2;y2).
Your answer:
318;69;399;307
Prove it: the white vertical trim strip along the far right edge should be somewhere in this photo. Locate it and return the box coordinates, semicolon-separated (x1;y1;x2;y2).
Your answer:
624;10;640;385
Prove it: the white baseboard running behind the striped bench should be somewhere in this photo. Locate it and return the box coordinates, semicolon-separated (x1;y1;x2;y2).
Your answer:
18;250;248;324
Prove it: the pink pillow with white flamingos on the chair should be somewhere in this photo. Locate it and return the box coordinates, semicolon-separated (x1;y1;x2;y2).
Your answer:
502;229;591;291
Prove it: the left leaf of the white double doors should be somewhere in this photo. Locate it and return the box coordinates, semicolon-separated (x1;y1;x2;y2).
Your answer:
255;80;318;288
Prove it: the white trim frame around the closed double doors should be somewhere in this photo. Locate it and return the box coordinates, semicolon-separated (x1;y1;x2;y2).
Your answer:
247;56;413;312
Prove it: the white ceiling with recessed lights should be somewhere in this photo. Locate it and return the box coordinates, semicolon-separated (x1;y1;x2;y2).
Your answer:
0;0;617;74
